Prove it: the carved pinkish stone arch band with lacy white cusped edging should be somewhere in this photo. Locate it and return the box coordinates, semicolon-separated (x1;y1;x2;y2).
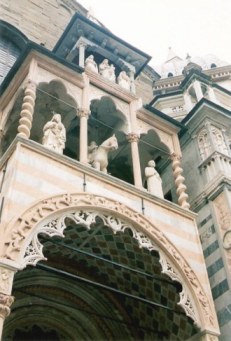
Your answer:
1;193;217;331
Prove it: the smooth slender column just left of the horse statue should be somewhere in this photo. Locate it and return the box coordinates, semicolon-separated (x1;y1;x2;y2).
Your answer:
77;109;89;164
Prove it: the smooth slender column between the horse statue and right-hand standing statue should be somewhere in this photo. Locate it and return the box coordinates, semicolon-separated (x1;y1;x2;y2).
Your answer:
127;133;143;188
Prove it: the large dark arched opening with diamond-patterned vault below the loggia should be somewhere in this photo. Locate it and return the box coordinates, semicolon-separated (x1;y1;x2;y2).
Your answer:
3;209;198;341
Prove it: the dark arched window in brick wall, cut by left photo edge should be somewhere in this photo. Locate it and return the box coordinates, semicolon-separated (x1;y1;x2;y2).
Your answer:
0;20;28;85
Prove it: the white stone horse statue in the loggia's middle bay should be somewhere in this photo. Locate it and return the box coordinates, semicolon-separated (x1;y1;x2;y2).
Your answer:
88;134;118;173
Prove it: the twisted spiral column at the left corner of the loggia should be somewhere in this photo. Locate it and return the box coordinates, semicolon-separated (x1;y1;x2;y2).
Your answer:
18;80;36;139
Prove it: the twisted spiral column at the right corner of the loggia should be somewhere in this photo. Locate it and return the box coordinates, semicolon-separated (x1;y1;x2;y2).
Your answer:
171;154;190;209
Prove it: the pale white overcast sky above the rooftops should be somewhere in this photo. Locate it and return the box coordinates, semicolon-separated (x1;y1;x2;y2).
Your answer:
77;0;231;66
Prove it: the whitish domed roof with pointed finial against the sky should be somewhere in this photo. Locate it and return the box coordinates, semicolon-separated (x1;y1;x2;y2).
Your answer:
154;47;229;78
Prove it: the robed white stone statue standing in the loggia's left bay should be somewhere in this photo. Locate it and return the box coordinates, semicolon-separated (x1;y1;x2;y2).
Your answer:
42;112;66;154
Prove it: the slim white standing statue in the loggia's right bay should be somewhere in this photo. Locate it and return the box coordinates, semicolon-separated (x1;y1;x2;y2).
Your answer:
145;160;164;198
